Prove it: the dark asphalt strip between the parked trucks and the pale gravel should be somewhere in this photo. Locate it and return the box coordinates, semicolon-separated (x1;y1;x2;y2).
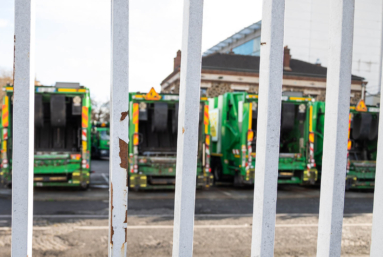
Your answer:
0;188;373;215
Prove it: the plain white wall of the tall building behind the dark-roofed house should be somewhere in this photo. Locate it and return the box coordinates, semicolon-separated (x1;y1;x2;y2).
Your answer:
284;0;383;94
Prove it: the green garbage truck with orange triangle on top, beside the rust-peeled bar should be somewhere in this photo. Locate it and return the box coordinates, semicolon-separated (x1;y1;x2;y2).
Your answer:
128;88;213;189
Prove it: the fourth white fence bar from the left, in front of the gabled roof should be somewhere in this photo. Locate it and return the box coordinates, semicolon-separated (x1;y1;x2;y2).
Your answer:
251;0;285;257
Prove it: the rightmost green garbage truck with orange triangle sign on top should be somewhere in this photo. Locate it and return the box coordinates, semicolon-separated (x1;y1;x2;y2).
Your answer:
310;100;379;190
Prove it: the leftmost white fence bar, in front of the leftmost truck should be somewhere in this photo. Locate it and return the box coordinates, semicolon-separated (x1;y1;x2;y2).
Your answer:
12;0;35;256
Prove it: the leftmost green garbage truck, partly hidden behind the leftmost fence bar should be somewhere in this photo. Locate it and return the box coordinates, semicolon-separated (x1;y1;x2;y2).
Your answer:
0;83;91;188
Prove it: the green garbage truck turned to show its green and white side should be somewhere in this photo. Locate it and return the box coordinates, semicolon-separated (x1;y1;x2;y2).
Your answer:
209;92;318;186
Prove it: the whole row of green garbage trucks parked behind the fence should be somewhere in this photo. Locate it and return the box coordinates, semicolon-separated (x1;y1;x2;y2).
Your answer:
0;85;379;190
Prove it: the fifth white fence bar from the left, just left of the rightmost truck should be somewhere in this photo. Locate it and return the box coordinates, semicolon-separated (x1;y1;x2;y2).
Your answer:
317;0;354;257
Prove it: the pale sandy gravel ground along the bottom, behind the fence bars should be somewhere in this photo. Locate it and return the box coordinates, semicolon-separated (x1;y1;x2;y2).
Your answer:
0;214;372;257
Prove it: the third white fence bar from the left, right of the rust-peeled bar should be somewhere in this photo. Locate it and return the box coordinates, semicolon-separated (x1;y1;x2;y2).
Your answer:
173;0;203;254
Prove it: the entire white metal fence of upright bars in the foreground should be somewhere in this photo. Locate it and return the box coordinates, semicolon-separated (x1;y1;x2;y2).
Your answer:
12;0;383;257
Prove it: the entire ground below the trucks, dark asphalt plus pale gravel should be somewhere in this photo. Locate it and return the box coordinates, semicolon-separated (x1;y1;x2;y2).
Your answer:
0;160;373;257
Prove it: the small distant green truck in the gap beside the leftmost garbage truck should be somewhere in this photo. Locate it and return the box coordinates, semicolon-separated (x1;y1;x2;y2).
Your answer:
92;122;110;159
